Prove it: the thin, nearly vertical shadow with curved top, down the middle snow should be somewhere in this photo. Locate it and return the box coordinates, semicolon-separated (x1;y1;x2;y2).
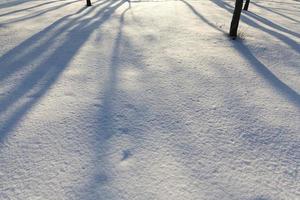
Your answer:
79;6;130;200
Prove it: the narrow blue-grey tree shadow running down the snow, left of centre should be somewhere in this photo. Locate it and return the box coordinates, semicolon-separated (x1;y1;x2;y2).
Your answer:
74;5;150;200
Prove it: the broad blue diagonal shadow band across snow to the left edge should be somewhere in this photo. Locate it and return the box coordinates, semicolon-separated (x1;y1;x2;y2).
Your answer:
0;1;124;142
